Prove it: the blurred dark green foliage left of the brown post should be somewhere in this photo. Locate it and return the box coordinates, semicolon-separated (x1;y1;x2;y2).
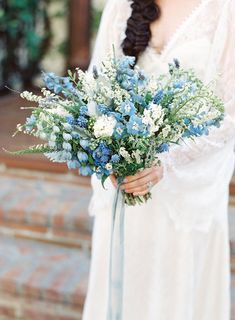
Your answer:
0;0;68;91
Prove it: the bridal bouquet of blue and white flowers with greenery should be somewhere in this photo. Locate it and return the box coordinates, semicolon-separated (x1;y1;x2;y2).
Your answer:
11;55;224;205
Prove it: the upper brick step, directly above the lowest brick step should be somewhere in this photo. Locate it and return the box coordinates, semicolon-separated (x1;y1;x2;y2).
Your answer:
0;170;92;247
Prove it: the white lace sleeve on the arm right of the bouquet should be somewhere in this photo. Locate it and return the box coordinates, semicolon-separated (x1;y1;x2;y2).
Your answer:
160;0;235;177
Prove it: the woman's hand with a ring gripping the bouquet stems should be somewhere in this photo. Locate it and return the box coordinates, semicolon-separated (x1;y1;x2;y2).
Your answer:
110;166;163;196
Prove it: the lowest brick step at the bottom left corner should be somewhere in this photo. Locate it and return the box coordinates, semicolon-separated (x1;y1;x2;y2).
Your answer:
0;236;89;320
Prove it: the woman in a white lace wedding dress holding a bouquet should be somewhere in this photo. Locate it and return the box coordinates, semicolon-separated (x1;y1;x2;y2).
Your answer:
83;0;235;320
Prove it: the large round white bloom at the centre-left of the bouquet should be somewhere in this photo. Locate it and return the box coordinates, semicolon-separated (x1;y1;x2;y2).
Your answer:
94;115;116;138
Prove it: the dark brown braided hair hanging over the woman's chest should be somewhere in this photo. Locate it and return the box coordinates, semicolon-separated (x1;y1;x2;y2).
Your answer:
122;0;161;62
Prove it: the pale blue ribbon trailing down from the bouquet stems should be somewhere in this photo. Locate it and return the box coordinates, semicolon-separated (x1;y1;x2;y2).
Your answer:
107;178;125;320
